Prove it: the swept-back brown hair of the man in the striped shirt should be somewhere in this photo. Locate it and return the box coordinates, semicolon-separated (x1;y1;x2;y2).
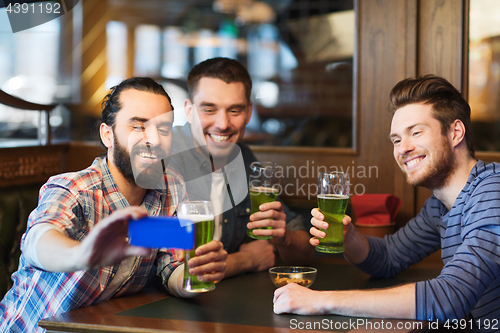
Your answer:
389;74;475;158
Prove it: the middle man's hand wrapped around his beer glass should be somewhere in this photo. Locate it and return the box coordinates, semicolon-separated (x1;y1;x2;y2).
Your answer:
247;201;286;241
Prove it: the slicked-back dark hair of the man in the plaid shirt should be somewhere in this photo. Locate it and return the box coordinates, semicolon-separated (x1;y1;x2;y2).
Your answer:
101;77;174;130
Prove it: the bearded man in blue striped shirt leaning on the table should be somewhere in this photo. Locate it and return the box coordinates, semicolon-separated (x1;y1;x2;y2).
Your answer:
274;75;500;329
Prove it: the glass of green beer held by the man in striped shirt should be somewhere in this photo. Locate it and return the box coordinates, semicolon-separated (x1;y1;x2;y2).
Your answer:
316;172;350;253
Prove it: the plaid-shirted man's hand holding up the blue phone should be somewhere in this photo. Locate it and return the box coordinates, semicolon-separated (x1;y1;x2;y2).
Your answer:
75;207;151;269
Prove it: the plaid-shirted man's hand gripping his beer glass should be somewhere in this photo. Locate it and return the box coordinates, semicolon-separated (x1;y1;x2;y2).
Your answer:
188;240;227;282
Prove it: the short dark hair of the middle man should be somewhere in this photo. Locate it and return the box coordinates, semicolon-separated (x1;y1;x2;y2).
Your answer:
187;57;252;102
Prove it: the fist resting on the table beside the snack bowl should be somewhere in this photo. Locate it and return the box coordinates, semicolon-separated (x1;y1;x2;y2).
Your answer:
273;283;324;315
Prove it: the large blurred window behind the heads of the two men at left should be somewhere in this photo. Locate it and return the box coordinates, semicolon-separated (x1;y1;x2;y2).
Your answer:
108;0;355;147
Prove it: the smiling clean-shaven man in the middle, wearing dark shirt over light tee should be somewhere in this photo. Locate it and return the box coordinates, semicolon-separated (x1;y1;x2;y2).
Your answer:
172;58;314;277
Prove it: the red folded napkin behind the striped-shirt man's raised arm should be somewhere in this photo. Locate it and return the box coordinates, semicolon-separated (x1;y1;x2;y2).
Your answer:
351;194;401;225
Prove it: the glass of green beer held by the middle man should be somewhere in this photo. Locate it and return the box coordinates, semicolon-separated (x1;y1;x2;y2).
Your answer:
247;162;281;239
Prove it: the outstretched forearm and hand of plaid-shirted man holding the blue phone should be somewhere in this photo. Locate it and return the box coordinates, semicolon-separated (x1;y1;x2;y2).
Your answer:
36;207;151;272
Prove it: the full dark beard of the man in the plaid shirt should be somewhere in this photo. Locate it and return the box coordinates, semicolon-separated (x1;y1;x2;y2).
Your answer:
113;135;168;189
